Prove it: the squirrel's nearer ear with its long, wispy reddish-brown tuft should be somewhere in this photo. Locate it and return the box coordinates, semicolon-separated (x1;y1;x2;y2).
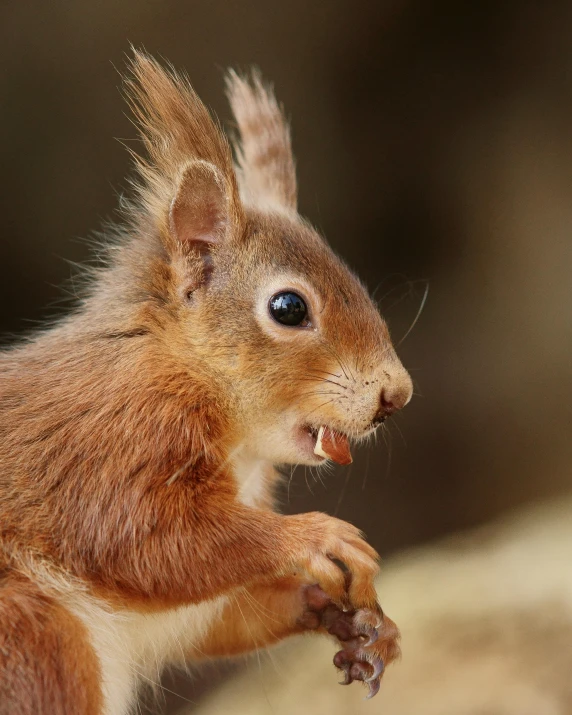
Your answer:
125;50;244;245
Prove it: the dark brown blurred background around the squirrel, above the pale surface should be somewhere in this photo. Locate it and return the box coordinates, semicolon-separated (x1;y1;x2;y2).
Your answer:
0;0;572;712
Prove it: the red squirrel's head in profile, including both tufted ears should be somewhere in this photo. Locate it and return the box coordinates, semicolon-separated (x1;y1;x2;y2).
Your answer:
115;53;412;465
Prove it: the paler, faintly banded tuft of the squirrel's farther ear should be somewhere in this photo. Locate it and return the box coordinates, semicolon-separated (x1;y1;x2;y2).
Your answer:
226;70;297;213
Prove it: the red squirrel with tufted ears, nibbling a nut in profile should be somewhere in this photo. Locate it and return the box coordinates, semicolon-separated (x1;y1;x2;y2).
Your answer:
0;51;412;715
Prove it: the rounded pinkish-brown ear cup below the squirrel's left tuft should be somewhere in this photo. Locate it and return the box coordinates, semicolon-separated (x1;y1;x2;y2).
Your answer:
169;160;229;254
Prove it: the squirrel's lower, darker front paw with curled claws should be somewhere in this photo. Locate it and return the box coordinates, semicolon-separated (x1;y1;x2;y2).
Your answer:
298;585;400;698
